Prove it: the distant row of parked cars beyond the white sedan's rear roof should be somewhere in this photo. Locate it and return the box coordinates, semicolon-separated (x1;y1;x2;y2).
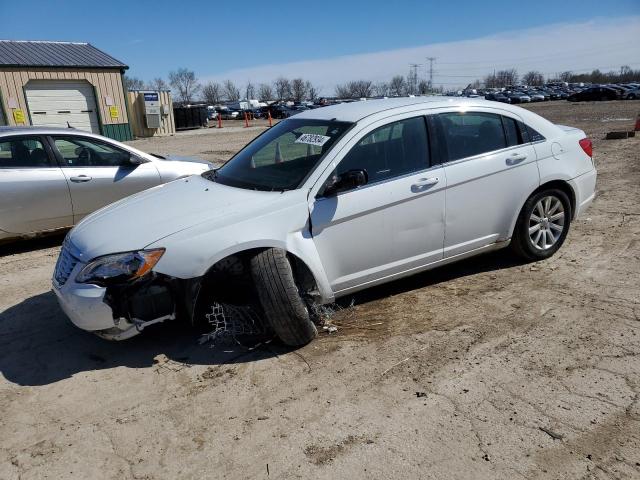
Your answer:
480;83;640;103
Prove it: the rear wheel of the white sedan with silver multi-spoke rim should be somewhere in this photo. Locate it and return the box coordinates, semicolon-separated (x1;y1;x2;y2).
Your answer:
511;188;572;261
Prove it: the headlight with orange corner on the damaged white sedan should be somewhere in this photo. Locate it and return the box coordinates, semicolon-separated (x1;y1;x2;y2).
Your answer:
76;248;164;285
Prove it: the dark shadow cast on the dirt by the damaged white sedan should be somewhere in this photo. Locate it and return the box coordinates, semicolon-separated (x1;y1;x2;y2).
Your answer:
0;252;518;385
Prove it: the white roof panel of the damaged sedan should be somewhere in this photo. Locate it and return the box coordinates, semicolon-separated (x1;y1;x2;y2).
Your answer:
295;96;504;122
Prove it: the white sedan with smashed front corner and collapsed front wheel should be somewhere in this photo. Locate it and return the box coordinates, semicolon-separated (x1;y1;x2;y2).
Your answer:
53;97;596;345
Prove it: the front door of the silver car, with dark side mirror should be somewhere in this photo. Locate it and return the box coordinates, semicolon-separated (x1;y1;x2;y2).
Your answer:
50;135;161;222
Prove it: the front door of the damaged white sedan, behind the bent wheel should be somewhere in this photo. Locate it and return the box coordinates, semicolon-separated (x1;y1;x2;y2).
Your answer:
310;116;446;294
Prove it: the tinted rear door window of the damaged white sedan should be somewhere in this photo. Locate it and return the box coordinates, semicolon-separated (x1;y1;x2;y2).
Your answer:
436;112;507;161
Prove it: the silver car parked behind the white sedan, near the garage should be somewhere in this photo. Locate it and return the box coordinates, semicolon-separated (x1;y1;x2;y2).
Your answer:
0;127;213;240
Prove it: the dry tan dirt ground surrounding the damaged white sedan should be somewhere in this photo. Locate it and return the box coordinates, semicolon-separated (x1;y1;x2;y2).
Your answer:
0;102;640;479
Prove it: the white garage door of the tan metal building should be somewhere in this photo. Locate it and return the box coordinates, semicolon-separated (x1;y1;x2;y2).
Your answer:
25;80;100;133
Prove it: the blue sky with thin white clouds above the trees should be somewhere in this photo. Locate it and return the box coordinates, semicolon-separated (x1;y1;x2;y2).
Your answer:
0;0;640;92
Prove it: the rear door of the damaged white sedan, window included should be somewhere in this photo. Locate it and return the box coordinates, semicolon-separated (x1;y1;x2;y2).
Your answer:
434;111;540;258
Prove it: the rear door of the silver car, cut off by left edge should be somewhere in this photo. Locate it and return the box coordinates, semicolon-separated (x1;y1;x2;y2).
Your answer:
0;135;73;234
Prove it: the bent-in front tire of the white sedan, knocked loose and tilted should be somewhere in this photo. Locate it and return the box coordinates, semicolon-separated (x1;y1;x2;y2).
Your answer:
251;248;318;347
